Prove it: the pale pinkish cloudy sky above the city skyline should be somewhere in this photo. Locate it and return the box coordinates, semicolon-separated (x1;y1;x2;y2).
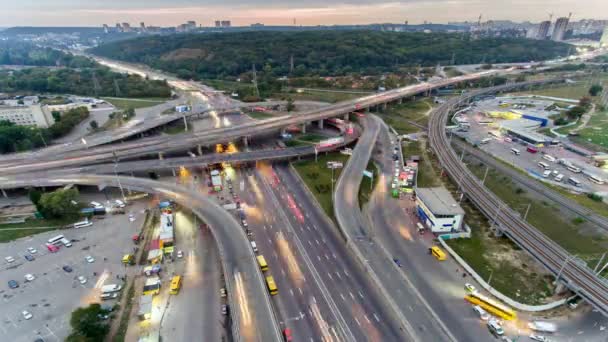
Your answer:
0;0;608;27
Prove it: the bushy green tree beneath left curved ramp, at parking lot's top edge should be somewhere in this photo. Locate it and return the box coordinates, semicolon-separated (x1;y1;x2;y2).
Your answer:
38;189;80;219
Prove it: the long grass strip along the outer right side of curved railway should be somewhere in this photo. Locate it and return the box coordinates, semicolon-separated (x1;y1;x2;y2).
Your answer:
468;163;608;262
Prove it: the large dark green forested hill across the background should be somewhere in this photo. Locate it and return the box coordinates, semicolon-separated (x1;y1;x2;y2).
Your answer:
91;30;569;79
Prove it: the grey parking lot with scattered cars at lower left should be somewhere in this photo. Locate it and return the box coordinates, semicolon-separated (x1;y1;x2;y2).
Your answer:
0;195;147;342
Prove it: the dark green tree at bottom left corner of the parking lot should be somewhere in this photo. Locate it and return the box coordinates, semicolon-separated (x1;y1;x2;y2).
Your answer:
66;303;110;342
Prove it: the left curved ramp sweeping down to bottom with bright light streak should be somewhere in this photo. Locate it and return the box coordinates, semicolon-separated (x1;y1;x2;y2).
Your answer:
0;174;281;342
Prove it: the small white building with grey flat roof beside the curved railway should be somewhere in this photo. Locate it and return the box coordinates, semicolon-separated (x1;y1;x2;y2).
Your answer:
416;187;464;233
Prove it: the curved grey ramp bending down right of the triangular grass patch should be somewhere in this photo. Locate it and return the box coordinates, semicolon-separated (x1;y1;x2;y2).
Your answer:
334;115;457;341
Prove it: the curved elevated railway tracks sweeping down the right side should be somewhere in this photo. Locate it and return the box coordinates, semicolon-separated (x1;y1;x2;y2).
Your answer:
429;81;608;315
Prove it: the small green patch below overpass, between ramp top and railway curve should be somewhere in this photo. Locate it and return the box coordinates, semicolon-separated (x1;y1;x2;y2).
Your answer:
378;99;433;134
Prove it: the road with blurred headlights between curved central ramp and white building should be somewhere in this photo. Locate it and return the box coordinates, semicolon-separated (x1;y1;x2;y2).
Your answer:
365;122;491;341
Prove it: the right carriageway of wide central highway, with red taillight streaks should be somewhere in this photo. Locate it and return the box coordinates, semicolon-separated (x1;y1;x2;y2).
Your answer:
274;164;408;341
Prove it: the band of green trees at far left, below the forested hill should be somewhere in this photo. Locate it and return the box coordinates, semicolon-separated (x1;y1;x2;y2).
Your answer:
0;66;171;97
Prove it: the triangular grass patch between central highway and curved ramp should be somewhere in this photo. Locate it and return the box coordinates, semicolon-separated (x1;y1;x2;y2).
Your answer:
292;152;349;219
